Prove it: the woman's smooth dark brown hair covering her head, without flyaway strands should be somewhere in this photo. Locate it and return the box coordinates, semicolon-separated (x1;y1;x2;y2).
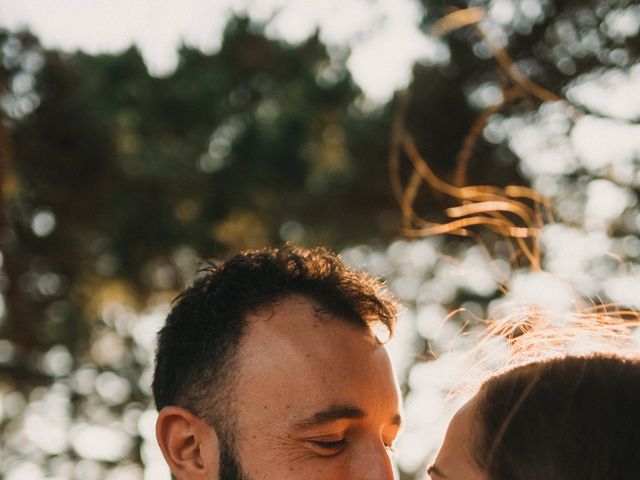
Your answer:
472;354;640;480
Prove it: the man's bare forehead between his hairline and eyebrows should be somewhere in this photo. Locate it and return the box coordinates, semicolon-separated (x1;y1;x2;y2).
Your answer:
232;298;396;410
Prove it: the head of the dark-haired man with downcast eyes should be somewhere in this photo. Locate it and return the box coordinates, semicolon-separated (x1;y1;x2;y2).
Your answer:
153;247;399;480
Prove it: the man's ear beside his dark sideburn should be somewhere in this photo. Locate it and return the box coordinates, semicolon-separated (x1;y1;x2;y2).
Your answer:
156;407;220;480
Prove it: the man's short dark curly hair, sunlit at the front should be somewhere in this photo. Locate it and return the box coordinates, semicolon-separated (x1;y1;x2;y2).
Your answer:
153;246;396;428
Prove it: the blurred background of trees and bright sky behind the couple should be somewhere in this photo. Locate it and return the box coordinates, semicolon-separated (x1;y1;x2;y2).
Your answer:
0;0;640;480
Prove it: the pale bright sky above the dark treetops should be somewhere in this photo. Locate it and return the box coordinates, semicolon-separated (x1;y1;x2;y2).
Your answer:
0;0;438;103
